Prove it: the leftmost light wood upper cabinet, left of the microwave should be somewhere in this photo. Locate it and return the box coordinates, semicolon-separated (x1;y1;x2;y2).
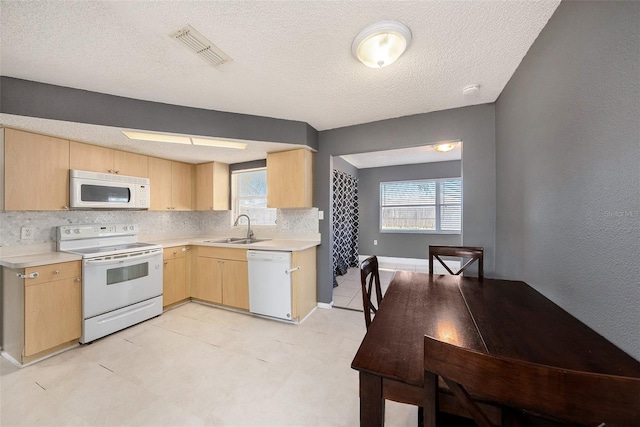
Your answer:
4;128;69;211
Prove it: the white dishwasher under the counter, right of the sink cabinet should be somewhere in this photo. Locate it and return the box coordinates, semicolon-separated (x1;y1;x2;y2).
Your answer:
247;250;296;320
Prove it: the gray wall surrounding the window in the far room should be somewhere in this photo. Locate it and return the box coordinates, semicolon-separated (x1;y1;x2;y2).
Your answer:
358;161;462;259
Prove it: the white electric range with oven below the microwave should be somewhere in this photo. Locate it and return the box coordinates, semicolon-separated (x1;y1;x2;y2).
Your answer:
57;224;163;343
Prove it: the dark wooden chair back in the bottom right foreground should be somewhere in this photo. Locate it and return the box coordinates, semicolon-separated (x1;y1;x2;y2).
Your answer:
424;336;640;427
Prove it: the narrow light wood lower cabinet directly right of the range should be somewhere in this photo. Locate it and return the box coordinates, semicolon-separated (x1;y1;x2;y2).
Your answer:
162;246;190;307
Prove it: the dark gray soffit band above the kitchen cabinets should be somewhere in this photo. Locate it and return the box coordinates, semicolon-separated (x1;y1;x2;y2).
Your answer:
0;76;318;149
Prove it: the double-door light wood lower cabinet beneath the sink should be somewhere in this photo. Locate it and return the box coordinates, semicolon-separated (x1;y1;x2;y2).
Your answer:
191;246;249;310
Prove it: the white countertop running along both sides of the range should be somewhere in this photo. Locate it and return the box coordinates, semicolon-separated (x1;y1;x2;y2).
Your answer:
0;234;320;268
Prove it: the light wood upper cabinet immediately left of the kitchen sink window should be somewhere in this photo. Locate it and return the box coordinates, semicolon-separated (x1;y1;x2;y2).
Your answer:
196;162;229;211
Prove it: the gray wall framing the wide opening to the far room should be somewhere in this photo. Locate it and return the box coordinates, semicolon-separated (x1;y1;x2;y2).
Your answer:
314;104;496;303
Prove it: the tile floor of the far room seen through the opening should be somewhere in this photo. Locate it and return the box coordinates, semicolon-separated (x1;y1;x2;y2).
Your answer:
333;262;430;311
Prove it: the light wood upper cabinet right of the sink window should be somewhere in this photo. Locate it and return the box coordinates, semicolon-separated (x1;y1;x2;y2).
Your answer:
267;148;313;208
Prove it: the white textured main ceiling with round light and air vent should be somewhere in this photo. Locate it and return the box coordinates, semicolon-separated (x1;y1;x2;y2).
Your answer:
0;0;559;164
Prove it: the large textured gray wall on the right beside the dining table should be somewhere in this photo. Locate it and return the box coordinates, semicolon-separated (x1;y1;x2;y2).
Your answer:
496;2;640;359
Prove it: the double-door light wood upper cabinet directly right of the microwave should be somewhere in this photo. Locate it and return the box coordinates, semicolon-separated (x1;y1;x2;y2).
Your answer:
149;157;194;211
